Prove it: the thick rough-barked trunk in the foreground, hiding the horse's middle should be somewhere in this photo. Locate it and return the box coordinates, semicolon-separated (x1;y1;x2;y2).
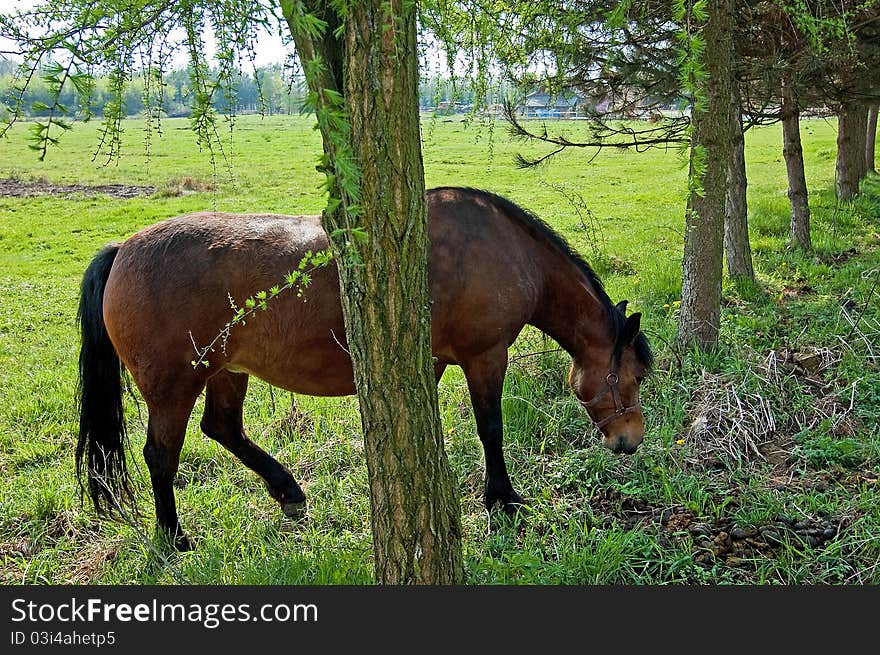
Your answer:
289;0;464;584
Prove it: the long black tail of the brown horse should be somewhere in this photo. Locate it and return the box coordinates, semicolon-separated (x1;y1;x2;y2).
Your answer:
76;244;134;515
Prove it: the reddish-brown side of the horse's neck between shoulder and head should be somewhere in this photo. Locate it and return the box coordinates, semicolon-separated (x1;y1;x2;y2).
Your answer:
530;250;613;361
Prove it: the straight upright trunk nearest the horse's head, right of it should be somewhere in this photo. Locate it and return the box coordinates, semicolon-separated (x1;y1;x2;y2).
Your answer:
678;0;734;350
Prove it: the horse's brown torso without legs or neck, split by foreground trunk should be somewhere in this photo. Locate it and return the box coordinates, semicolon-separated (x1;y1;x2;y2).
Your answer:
104;197;540;395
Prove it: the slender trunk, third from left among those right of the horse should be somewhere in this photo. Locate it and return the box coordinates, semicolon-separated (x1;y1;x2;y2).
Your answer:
782;75;812;250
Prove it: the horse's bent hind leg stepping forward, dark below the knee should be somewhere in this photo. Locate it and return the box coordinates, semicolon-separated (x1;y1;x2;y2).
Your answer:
201;371;306;518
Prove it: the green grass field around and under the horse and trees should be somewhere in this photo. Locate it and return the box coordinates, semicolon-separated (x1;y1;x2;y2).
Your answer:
0;111;880;584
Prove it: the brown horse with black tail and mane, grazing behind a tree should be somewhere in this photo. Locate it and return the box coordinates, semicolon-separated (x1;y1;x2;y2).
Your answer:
76;188;651;550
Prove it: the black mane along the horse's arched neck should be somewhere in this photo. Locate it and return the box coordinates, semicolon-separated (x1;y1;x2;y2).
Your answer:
429;187;654;369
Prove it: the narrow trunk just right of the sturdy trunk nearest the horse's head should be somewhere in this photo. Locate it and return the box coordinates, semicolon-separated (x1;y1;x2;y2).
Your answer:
724;80;755;280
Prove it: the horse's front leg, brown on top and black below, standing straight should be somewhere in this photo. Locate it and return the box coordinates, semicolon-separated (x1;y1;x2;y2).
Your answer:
462;347;525;515
